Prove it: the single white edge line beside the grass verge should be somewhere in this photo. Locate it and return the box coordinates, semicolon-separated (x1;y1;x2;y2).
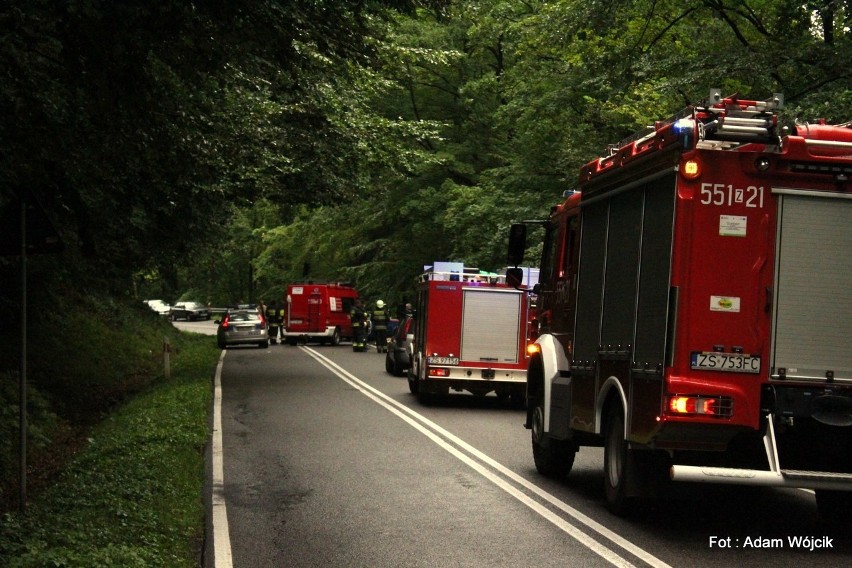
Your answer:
212;349;233;568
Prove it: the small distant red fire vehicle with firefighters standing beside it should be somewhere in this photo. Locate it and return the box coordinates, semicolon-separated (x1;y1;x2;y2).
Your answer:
283;282;358;345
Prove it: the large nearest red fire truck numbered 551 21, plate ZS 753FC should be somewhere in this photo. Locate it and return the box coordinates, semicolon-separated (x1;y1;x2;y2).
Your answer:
509;90;852;522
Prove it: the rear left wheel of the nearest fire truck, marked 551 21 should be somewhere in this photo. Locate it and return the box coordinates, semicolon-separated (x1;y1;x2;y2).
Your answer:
604;405;634;516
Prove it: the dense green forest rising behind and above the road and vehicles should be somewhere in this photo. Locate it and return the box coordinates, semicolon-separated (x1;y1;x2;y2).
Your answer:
0;0;852;502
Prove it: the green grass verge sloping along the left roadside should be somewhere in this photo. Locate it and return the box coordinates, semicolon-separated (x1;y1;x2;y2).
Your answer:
0;334;219;568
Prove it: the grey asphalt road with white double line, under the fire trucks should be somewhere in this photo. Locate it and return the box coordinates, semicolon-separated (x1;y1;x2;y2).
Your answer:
183;322;852;568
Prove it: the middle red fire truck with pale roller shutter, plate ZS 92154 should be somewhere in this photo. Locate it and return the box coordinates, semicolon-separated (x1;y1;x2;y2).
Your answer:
408;263;528;406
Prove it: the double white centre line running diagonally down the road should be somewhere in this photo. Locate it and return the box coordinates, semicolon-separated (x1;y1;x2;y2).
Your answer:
302;346;670;568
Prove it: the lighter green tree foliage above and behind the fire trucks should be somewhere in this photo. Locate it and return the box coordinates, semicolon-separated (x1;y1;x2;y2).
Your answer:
195;0;852;310
